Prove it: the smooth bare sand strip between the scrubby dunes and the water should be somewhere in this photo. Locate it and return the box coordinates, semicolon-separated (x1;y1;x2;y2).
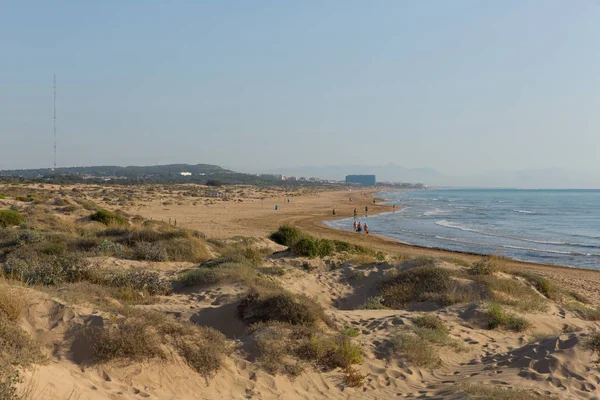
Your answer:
131;189;600;303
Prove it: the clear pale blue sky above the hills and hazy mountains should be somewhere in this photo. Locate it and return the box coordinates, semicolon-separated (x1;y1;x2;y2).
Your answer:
0;0;600;174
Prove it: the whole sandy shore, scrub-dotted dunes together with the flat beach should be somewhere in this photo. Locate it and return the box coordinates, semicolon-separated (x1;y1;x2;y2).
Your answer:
0;185;600;400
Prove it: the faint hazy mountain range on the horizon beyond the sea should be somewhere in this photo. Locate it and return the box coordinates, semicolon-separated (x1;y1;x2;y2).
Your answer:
264;163;600;189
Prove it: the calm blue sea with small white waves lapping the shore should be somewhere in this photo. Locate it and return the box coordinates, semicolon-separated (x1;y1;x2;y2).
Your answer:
328;189;600;269
